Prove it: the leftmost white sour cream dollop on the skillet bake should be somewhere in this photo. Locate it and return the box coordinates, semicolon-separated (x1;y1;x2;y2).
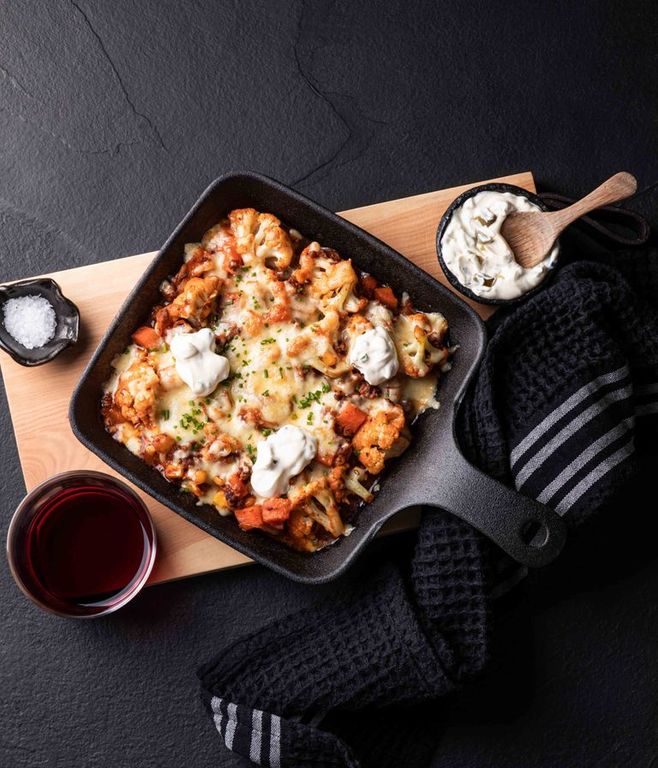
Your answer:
169;328;230;397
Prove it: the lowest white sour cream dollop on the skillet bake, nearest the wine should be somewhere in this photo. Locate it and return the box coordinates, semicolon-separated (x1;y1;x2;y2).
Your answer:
251;425;318;498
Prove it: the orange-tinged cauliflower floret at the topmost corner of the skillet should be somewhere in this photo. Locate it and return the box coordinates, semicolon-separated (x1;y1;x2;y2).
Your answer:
229;208;293;269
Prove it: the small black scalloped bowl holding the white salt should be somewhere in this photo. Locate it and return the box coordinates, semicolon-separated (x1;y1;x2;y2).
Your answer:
0;277;80;366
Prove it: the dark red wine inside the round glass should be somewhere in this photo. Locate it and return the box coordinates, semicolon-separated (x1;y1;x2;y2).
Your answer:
25;483;151;613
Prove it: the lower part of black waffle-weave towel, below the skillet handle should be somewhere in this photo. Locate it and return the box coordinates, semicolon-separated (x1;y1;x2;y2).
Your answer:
200;512;490;768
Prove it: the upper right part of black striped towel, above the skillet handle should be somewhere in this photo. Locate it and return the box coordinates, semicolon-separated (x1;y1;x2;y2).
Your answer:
459;251;658;523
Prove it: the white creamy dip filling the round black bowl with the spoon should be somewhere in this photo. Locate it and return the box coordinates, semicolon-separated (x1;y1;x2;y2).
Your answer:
441;190;558;299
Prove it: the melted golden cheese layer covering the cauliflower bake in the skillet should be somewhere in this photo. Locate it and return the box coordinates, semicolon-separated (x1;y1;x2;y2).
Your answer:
105;207;447;548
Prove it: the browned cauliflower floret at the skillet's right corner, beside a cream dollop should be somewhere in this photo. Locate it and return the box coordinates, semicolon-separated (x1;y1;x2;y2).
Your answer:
393;312;450;379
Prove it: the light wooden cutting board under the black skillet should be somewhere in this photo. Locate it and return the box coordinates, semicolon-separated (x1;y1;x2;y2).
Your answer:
0;172;535;584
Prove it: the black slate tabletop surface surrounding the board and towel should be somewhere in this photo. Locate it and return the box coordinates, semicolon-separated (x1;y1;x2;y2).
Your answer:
0;0;658;768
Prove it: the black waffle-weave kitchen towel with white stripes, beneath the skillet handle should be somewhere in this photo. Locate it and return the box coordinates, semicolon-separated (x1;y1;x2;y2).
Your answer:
199;250;658;768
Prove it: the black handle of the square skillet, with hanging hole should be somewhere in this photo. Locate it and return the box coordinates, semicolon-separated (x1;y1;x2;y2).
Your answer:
429;445;566;568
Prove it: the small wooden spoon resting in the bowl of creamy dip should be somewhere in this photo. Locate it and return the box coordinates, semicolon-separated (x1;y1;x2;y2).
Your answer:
500;172;637;269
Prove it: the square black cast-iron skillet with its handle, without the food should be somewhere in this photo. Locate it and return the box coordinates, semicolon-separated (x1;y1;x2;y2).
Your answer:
69;173;565;584
